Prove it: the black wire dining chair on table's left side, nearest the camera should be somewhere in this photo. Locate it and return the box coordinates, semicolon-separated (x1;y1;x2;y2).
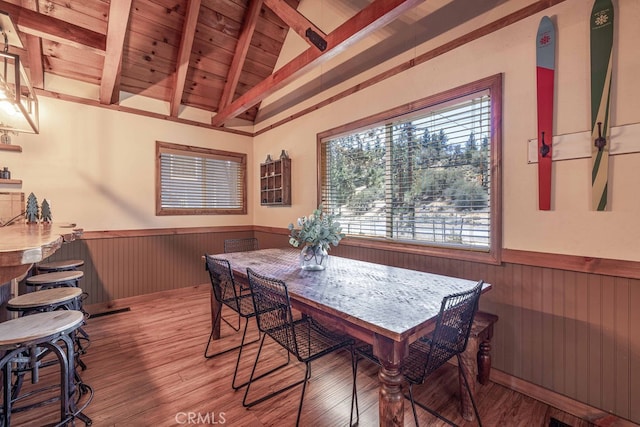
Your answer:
242;268;357;426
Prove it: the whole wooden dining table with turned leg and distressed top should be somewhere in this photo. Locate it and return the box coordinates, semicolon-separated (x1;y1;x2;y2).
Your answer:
211;248;491;426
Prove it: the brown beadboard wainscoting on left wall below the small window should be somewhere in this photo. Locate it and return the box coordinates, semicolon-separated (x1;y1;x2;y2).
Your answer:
39;227;262;314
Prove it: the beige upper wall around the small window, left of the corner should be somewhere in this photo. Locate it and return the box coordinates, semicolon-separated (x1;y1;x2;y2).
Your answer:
5;97;254;231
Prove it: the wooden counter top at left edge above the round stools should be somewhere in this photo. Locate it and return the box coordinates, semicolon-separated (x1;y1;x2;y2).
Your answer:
0;224;82;284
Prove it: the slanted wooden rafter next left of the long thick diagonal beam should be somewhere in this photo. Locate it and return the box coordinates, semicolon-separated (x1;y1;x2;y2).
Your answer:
218;0;262;111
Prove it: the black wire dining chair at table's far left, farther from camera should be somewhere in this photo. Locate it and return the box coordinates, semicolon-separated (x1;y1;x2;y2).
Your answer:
204;254;260;390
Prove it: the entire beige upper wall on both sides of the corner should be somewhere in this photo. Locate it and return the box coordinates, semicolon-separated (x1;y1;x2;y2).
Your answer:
6;0;640;261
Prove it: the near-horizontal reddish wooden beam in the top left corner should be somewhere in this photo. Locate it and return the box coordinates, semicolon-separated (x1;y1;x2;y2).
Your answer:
0;0;105;55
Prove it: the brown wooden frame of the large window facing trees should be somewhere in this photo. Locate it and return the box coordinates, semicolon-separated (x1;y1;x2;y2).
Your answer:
316;74;502;265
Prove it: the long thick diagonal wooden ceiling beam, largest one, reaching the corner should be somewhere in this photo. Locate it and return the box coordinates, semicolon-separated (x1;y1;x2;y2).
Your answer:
211;0;424;126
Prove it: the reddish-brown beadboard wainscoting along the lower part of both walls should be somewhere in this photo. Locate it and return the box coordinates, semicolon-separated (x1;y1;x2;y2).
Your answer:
38;226;640;423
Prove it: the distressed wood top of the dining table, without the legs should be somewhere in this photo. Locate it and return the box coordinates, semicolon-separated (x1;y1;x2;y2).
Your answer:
215;249;490;341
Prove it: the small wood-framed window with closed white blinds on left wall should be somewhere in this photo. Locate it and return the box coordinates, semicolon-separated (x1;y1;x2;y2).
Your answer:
156;141;247;215
